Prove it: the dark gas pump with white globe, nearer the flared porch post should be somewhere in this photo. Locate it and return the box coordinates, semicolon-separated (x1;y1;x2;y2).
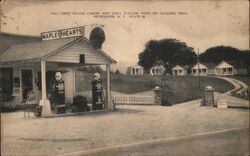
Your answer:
53;72;66;113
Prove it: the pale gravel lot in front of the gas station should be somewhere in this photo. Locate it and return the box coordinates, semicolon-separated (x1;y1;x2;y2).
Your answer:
1;101;249;156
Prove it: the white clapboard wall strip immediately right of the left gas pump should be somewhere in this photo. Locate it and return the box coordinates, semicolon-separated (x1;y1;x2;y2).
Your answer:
62;70;74;103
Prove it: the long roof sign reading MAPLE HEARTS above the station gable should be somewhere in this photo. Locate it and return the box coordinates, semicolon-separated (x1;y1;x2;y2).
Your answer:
41;27;84;40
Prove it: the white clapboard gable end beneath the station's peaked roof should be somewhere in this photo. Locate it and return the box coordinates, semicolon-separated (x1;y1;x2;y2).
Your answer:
46;40;109;64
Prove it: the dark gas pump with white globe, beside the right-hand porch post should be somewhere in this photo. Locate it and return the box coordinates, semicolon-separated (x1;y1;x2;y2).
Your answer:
92;73;103;110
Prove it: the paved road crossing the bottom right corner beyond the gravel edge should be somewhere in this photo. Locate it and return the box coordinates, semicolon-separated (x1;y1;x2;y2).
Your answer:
61;127;250;156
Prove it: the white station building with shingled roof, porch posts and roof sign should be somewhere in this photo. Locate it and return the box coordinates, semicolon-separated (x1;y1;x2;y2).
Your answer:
0;27;116;116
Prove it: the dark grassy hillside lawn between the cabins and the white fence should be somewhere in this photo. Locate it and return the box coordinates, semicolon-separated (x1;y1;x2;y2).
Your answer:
76;72;234;105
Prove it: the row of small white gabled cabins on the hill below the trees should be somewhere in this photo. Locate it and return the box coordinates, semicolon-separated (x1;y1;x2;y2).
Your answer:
127;61;247;76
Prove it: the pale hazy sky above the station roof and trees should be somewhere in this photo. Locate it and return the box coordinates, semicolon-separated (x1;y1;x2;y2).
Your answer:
1;0;249;72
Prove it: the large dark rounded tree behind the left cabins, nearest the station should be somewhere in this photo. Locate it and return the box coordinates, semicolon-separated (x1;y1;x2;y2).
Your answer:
138;39;196;71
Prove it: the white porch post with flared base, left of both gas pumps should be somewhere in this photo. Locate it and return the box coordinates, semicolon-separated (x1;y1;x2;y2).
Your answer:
39;61;51;116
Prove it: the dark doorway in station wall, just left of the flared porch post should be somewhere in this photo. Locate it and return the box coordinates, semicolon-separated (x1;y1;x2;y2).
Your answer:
21;69;33;100
